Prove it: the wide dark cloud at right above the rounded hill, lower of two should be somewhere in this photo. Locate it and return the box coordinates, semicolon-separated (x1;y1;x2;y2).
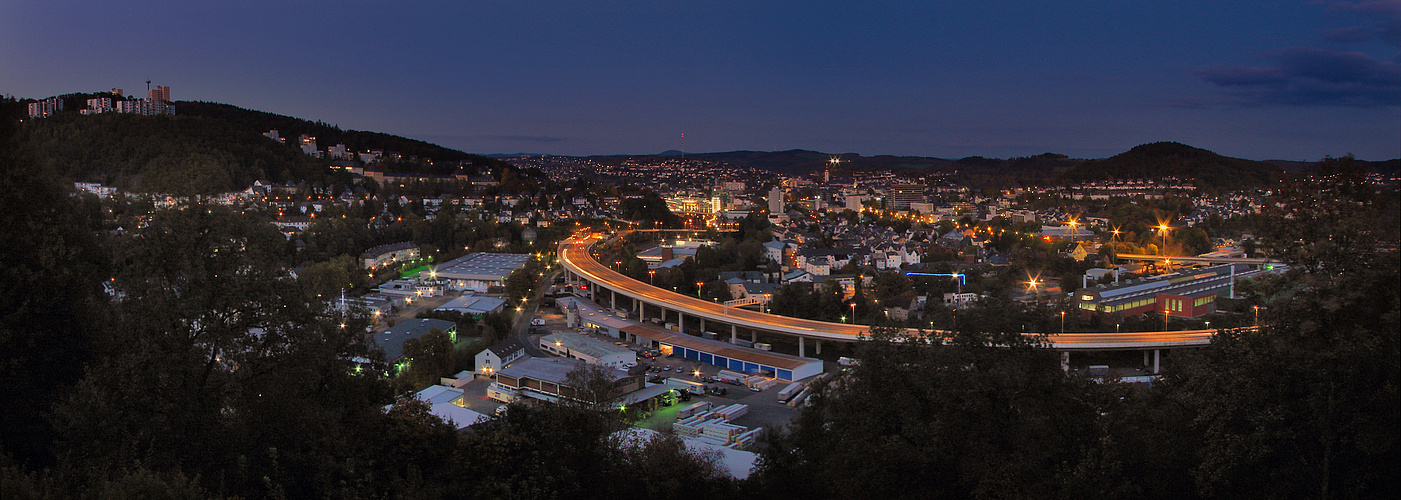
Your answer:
1195;48;1401;108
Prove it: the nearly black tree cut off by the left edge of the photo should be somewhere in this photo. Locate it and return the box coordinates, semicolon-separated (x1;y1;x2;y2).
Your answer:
0;151;111;465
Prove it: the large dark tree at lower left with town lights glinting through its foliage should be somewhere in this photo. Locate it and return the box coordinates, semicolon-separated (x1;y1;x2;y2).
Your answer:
52;204;388;496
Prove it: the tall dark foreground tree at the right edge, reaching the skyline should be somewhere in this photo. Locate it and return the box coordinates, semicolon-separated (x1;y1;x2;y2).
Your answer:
1168;158;1401;497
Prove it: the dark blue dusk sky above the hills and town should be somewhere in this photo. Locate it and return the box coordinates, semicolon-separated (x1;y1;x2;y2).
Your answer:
0;0;1401;160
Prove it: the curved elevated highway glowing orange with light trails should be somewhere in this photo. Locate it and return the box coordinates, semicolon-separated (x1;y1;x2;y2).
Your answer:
558;237;1215;350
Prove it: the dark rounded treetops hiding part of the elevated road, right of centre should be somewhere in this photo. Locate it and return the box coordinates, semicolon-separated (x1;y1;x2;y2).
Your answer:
758;322;1097;497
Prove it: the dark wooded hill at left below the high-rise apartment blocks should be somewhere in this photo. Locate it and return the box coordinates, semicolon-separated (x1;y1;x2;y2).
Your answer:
8;101;509;195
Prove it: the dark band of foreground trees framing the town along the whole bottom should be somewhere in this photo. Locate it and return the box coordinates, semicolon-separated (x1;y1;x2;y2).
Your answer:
0;100;1401;499
